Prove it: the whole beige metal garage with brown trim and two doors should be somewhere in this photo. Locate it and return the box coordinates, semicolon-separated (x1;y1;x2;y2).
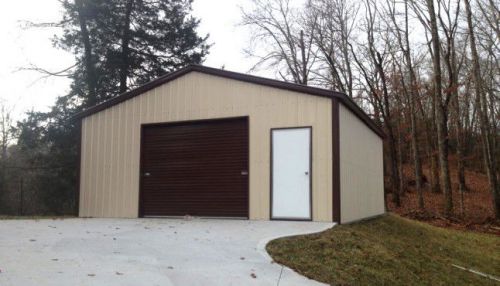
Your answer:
76;65;385;223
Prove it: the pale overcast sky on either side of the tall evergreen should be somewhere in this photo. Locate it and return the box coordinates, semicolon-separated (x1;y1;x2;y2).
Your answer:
0;0;265;121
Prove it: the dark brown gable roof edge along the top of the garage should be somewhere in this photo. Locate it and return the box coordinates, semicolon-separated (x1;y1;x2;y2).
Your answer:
73;65;385;138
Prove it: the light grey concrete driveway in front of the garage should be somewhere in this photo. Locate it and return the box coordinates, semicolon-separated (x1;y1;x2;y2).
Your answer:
0;219;333;286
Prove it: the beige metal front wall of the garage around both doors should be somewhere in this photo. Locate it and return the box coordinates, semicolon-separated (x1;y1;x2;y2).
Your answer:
80;72;332;221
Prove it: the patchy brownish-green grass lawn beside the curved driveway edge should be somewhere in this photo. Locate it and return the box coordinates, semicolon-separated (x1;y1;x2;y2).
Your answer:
266;215;500;285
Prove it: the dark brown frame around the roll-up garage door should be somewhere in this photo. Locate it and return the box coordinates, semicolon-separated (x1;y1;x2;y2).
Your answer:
137;115;250;220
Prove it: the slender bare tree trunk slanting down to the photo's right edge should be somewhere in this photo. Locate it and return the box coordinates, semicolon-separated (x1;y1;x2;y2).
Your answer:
464;0;500;219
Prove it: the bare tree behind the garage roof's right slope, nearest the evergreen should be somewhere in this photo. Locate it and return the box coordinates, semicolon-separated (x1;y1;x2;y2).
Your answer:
242;0;317;84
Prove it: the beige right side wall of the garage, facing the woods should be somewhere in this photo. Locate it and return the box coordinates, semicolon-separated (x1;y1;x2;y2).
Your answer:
339;104;385;223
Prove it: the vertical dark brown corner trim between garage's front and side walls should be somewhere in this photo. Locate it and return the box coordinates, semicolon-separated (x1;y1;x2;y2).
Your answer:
332;98;341;224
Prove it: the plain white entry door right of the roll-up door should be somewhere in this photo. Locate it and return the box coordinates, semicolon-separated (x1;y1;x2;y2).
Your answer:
271;127;311;220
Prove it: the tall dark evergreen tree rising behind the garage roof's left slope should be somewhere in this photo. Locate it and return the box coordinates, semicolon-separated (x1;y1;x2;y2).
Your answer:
59;0;210;106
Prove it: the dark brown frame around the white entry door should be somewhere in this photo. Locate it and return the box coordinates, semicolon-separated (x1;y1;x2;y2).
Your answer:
269;126;313;221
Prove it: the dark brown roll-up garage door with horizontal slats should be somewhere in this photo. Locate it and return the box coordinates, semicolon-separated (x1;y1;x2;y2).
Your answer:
139;118;248;217
